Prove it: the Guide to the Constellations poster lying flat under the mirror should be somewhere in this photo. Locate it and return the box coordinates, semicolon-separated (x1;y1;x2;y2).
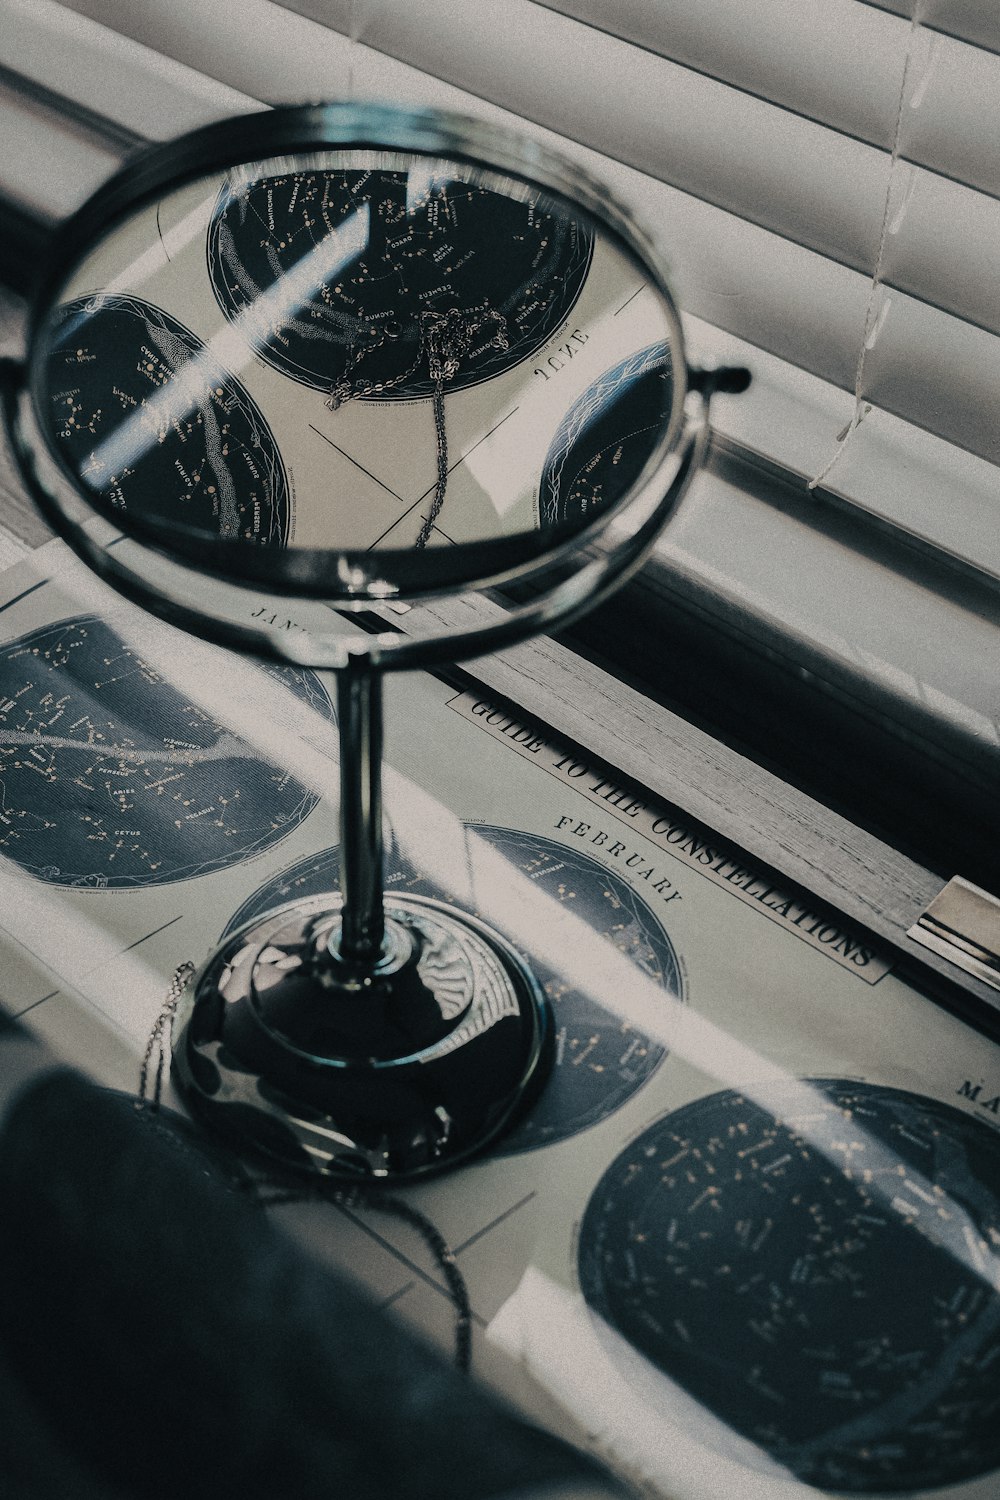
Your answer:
0;543;1000;1500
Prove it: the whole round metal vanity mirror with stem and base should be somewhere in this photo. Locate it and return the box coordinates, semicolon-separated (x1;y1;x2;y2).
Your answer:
4;105;747;1178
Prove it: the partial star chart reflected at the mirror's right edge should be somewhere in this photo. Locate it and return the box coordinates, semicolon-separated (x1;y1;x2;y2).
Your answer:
538;344;673;527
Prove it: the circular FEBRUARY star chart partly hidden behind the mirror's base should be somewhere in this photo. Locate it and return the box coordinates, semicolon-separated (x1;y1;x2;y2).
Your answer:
225;824;681;1152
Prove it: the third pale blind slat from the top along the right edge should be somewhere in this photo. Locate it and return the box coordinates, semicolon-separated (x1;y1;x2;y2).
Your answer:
275;0;1000;333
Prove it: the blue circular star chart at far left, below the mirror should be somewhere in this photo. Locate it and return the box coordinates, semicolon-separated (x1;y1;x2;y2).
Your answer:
0;617;333;890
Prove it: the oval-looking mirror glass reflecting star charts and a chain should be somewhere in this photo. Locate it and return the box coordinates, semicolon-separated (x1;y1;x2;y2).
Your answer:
33;149;682;579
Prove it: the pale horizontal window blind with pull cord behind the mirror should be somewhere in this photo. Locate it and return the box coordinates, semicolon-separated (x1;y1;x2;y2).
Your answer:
0;0;1000;858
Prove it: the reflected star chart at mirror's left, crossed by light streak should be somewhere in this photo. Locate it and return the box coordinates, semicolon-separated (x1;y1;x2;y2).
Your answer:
43;294;289;545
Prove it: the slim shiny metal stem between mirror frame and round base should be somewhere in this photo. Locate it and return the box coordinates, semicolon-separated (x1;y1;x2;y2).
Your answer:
337;657;385;965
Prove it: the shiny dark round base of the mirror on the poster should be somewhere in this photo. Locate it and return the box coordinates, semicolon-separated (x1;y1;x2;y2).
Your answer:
172;894;553;1184
